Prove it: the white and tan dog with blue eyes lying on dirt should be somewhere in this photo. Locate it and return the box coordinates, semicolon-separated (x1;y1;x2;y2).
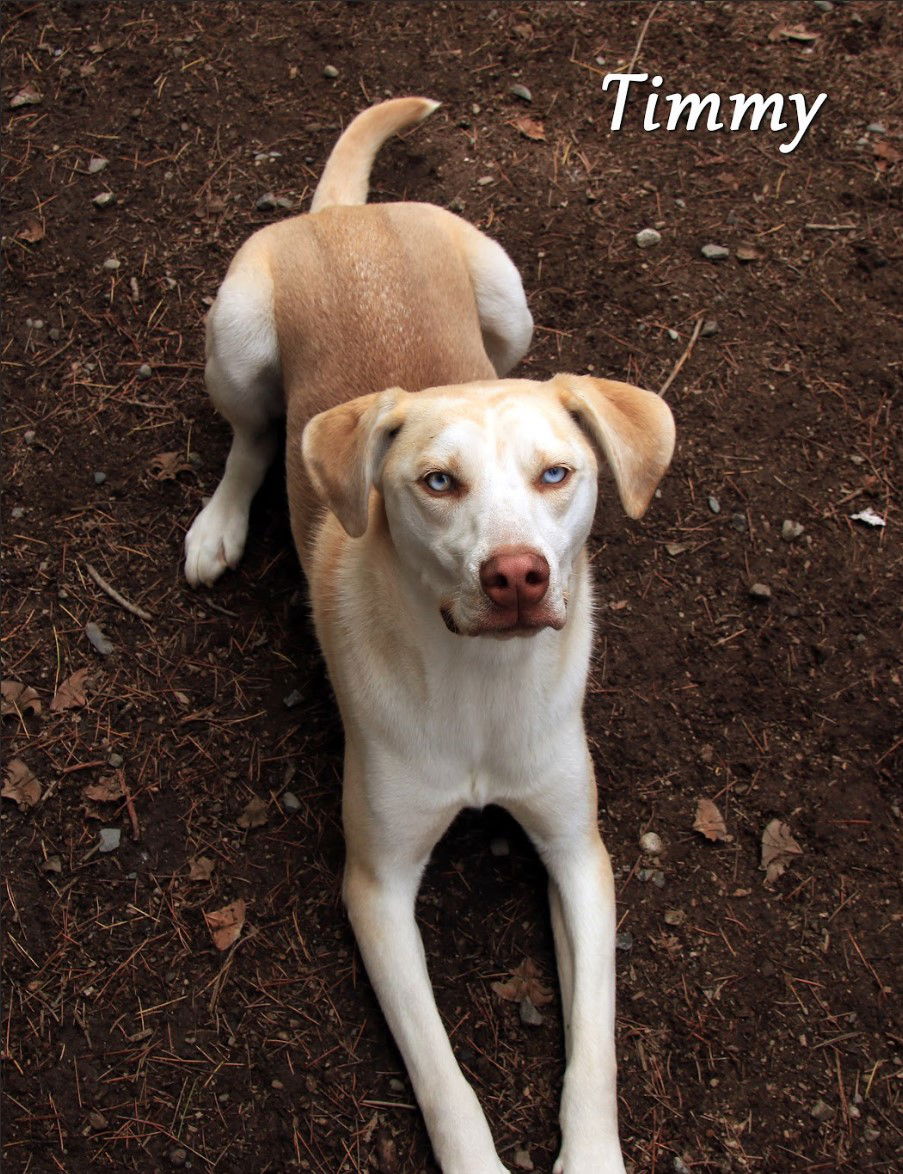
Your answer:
186;97;674;1174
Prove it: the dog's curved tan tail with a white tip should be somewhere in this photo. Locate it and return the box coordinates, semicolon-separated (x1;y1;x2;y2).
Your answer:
310;97;439;212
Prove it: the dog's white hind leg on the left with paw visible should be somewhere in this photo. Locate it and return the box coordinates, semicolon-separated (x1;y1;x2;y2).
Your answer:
186;265;284;587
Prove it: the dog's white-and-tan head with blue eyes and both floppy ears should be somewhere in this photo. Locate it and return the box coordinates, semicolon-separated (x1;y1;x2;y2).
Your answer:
302;375;674;636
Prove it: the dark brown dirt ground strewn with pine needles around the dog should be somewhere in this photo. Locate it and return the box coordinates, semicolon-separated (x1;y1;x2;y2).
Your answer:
1;0;903;1174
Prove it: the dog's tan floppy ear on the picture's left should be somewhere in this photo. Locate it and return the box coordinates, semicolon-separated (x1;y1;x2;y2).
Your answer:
301;387;407;538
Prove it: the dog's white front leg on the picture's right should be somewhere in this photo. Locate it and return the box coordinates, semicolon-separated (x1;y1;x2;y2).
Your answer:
508;754;624;1174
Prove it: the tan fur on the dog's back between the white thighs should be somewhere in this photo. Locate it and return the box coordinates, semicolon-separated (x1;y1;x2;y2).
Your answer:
267;204;494;551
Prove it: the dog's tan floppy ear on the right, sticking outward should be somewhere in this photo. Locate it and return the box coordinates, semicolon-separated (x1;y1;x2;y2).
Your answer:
552;375;674;518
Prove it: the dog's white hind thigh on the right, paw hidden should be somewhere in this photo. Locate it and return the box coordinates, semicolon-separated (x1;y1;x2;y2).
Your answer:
461;221;533;378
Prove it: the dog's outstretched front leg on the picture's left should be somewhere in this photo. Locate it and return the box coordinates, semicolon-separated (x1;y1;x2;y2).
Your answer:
343;755;505;1174
